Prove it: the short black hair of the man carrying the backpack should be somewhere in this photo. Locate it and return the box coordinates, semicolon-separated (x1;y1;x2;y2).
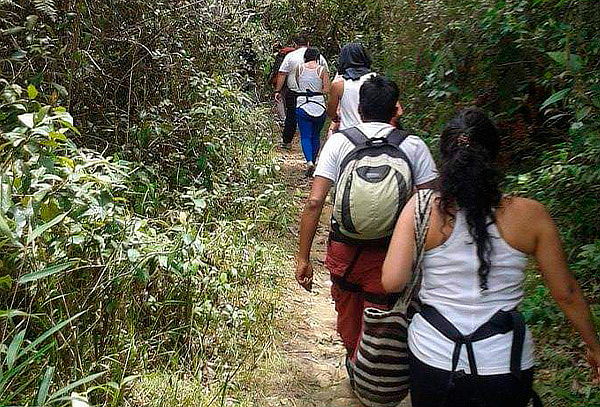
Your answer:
358;75;400;123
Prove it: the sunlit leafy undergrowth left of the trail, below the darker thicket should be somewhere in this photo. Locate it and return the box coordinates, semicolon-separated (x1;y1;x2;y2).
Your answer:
0;81;292;405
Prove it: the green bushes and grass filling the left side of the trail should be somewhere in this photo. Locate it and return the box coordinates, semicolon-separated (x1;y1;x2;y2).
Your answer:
0;1;293;406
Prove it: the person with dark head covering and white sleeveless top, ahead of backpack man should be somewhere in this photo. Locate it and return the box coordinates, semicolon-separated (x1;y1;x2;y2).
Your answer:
327;42;375;131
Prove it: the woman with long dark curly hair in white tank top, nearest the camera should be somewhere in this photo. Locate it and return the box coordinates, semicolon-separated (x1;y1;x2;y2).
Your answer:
382;108;600;407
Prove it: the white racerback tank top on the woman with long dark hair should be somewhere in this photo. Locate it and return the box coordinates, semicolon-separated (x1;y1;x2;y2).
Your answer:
408;211;534;375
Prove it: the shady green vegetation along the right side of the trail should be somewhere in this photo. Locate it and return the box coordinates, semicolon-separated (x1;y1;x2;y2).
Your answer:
269;0;600;406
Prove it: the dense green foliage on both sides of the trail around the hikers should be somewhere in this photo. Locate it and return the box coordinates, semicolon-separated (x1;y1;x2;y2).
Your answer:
0;0;600;406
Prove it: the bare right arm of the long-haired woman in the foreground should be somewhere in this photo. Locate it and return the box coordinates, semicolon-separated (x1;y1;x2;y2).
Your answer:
532;202;600;380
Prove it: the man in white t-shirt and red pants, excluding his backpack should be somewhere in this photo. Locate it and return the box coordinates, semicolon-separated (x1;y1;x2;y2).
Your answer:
296;76;437;355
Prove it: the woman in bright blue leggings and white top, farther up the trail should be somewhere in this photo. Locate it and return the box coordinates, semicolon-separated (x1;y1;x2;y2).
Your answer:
295;48;330;177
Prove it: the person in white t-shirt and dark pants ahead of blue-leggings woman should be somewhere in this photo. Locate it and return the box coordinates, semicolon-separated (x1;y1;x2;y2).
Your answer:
275;37;327;149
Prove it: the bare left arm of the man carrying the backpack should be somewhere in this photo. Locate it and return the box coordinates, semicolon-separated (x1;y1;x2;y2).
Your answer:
296;176;332;291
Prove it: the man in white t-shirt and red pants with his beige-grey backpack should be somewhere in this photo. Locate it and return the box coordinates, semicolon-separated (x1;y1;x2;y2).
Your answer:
296;76;437;355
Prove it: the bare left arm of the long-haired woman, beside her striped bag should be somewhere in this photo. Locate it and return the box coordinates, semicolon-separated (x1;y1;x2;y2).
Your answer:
381;195;416;293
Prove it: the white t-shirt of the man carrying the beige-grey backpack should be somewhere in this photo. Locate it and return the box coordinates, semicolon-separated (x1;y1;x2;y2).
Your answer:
314;122;438;185
